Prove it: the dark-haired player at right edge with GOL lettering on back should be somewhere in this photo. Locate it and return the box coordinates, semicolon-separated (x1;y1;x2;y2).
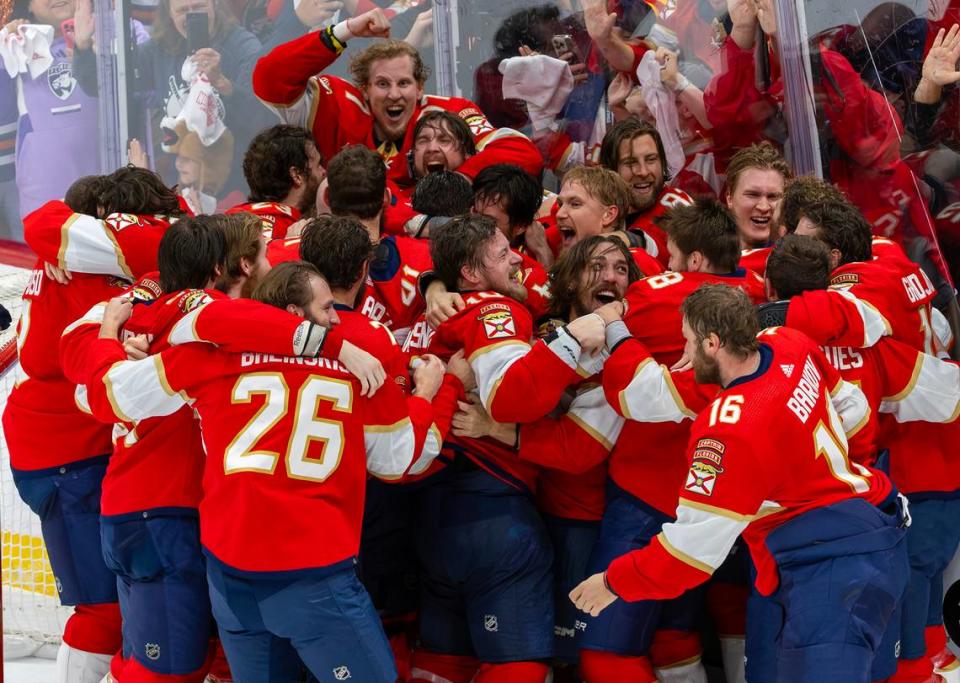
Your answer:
787;202;960;681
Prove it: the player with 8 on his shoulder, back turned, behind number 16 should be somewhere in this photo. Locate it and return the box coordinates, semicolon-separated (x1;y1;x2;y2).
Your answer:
578;199;764;681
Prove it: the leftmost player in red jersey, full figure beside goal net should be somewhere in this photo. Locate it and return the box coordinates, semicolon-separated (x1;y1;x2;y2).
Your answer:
3;168;180;683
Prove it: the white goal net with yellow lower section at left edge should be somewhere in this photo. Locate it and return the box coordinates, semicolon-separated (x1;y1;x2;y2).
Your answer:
0;264;72;659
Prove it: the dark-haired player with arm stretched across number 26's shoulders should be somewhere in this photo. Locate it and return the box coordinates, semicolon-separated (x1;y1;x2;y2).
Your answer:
61;215;348;683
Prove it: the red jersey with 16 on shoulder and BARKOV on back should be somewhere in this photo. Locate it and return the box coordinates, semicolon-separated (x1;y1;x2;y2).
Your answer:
607;328;892;600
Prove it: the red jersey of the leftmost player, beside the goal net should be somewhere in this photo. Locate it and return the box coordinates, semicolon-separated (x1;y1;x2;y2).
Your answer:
3;201;176;470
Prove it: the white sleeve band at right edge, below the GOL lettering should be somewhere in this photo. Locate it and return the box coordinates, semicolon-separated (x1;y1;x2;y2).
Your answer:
880;353;960;422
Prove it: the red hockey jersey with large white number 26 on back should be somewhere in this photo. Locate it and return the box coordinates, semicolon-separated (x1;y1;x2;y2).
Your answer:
88;340;436;572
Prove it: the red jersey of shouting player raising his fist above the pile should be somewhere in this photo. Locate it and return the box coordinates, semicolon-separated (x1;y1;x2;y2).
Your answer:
253;33;543;186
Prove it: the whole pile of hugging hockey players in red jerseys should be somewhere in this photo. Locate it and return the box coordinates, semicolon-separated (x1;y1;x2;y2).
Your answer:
0;0;960;683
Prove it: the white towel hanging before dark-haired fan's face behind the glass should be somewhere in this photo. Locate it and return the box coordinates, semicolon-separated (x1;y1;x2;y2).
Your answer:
498;55;573;130
